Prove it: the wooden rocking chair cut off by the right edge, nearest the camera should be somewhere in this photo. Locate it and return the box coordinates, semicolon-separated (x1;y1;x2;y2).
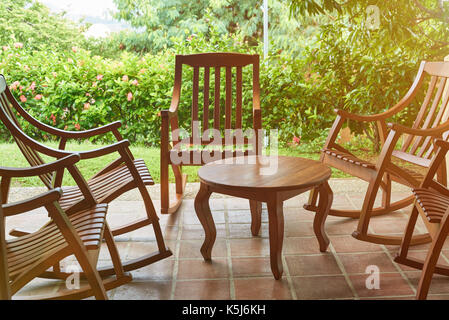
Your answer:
395;140;449;300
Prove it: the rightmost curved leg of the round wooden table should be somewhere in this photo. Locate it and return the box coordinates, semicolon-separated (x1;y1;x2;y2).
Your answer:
313;182;334;252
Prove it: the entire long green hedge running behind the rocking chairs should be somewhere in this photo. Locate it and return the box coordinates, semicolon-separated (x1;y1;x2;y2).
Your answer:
0;26;417;146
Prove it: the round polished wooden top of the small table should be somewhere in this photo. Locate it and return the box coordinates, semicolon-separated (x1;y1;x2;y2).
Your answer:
198;156;331;191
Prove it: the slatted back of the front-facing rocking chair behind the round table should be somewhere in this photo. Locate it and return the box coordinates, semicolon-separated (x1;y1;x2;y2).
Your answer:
171;53;262;161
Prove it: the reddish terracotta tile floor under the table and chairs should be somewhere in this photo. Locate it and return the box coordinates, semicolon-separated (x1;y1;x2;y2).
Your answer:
7;188;449;299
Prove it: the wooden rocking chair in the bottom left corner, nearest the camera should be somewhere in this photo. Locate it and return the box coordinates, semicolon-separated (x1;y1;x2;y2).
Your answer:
0;154;131;299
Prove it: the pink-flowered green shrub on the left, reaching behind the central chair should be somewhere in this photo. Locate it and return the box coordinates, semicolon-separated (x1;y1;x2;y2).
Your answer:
0;29;264;145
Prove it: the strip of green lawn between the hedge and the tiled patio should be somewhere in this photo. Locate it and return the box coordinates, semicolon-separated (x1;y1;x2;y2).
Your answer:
0;143;348;187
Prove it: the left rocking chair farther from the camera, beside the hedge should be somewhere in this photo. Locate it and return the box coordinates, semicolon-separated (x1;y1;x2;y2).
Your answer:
0;75;172;277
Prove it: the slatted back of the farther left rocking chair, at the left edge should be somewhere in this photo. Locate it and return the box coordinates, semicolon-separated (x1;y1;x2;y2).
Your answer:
0;75;53;189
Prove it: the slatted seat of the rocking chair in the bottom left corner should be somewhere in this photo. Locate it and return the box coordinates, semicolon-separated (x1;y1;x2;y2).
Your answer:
6;204;108;278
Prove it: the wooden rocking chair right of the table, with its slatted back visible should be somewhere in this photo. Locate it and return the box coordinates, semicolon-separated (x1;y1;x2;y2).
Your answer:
305;62;449;245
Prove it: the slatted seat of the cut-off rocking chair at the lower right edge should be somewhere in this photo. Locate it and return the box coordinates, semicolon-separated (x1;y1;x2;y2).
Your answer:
413;189;449;223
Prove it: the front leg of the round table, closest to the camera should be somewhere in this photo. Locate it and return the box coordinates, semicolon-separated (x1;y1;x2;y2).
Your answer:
267;196;284;280
